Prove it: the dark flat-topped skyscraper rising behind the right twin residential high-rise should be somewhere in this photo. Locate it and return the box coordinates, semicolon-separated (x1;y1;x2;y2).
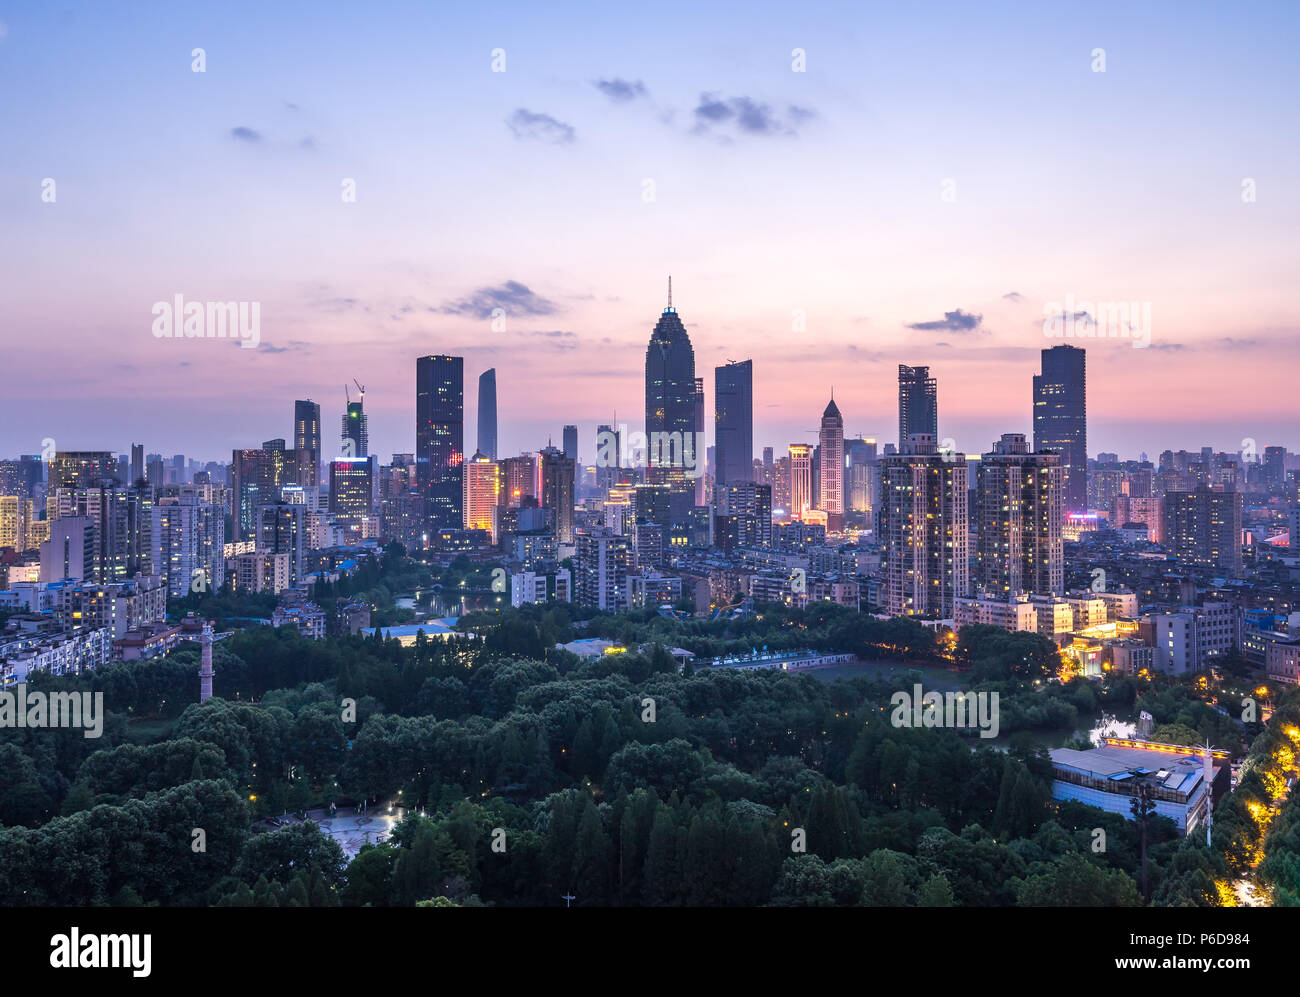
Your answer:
1034;344;1088;512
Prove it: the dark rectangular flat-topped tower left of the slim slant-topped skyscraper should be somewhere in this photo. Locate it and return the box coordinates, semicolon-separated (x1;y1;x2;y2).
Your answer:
415;356;465;538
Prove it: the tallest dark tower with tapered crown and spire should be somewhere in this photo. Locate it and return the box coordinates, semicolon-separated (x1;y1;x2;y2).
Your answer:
646;279;705;528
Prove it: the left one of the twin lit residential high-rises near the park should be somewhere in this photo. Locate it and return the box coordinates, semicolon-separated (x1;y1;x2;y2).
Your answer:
879;433;970;619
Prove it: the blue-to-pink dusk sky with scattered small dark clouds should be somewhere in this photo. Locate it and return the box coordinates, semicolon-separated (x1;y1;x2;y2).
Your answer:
0;0;1300;461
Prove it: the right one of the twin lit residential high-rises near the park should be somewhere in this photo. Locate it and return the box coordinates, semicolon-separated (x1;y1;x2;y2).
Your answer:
975;433;1065;597
